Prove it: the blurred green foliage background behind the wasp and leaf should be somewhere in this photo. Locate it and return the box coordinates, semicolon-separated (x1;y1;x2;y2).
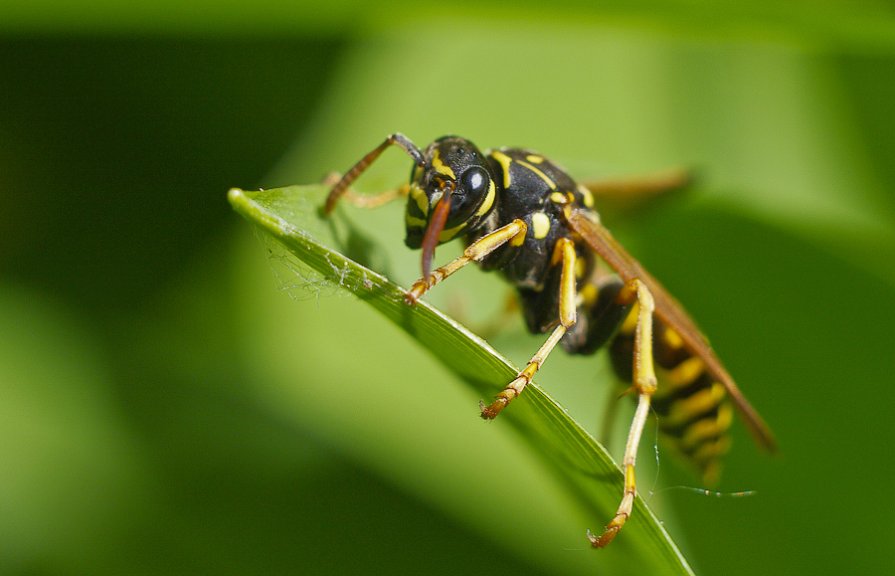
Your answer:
0;0;895;574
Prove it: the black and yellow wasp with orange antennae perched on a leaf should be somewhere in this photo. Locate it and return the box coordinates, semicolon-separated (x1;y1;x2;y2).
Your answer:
324;133;775;548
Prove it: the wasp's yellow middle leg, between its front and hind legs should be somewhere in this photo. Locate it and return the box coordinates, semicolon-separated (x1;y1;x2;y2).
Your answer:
481;238;577;420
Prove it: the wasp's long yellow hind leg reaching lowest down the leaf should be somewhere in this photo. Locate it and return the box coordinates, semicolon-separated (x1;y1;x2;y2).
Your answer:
587;279;656;548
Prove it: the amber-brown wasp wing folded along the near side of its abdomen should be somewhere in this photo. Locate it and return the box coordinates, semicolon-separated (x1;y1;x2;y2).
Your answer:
565;206;777;451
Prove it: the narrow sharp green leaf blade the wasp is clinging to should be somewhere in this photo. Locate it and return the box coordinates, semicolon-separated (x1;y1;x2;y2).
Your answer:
229;186;692;574
